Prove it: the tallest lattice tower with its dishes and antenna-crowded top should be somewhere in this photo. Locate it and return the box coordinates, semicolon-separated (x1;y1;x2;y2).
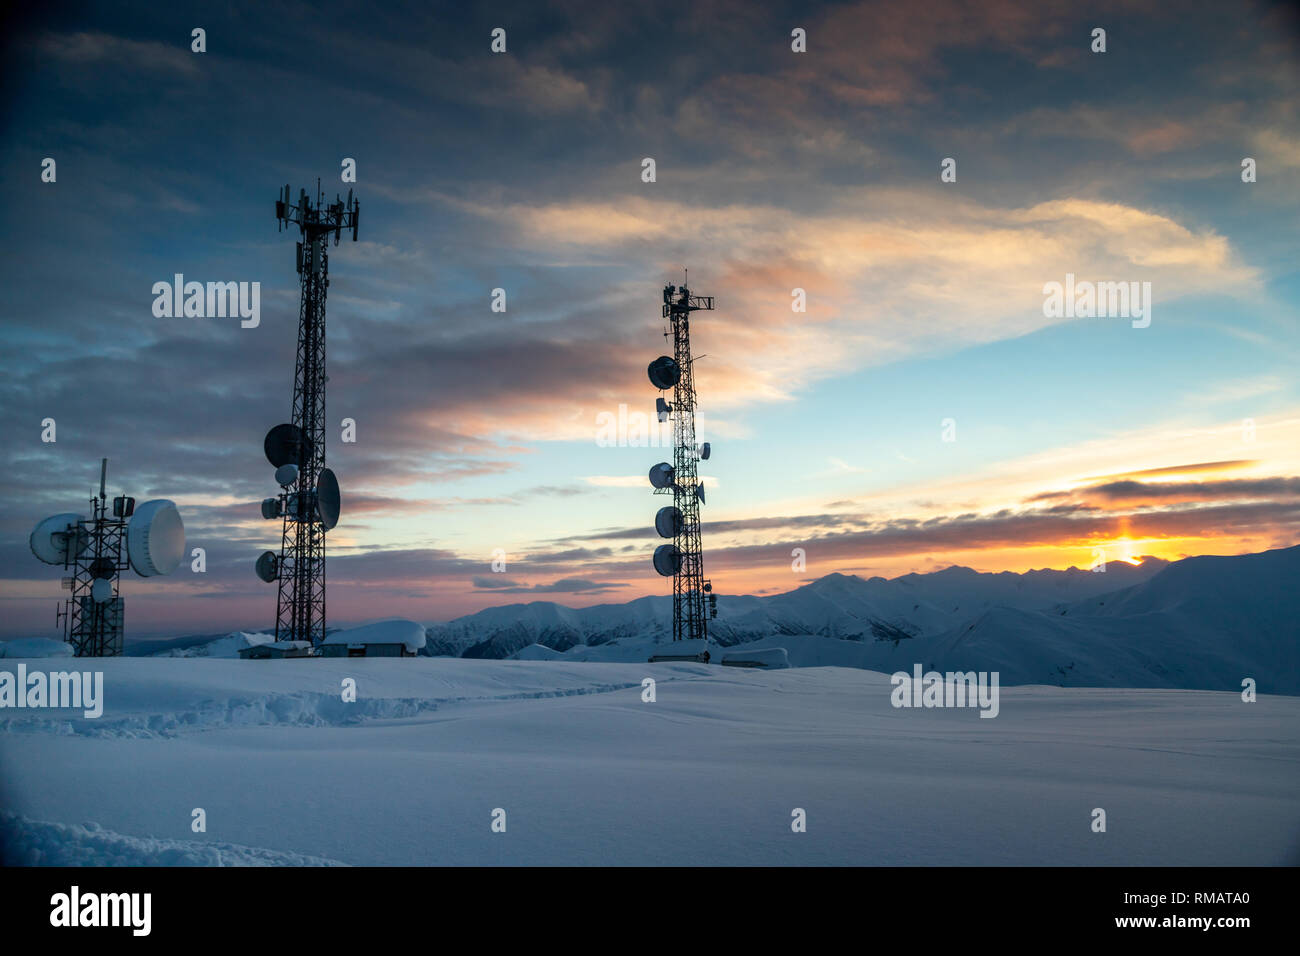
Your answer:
257;183;361;644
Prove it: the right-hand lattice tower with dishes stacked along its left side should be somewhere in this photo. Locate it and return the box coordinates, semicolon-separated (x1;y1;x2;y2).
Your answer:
649;284;718;650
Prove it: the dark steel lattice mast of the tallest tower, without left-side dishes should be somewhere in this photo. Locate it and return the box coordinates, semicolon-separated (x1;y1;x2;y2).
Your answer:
276;183;360;644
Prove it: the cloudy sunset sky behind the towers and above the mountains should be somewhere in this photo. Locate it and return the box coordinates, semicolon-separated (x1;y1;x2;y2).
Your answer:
0;0;1300;637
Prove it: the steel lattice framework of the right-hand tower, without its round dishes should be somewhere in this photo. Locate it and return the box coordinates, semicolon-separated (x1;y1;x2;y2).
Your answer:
655;285;714;641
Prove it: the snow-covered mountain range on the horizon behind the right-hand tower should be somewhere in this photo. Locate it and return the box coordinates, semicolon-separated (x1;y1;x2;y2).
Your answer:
425;546;1300;693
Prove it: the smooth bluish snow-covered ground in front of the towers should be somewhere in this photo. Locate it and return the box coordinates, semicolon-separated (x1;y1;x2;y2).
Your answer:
0;653;1300;865
